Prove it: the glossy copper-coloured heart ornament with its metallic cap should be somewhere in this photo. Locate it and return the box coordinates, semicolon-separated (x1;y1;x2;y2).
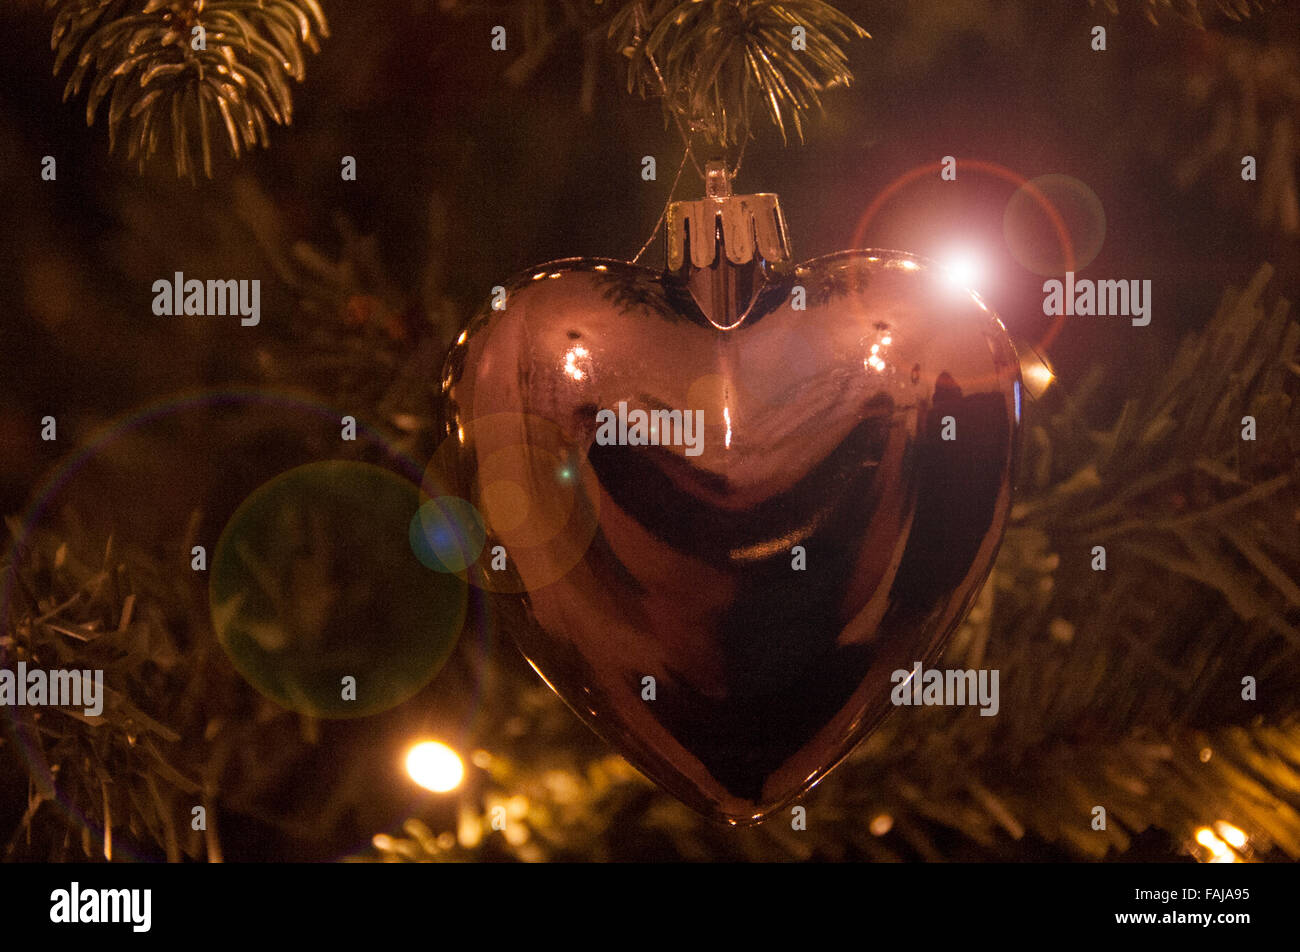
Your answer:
438;168;1021;823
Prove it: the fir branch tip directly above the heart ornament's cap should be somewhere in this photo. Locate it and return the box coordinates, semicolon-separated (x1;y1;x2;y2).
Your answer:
608;0;868;146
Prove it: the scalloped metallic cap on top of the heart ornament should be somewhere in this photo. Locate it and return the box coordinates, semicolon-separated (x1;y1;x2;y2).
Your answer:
667;163;790;271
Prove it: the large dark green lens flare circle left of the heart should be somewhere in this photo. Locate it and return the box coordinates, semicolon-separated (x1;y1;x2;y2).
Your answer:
211;460;468;717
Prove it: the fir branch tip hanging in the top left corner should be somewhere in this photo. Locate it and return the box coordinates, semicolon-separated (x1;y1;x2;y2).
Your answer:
46;0;329;181
